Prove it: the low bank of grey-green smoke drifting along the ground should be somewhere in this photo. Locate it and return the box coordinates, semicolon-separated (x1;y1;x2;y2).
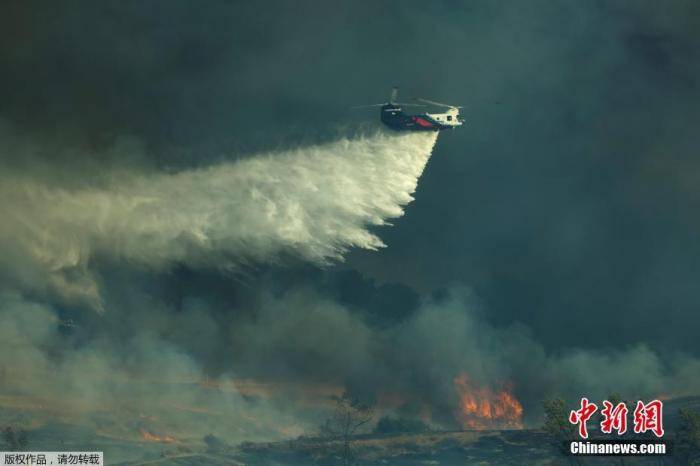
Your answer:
0;287;700;453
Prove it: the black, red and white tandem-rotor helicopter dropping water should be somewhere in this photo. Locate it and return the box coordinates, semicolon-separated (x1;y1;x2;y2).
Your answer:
353;87;464;131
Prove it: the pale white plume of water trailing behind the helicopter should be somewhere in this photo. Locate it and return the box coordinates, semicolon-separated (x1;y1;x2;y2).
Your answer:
0;132;437;309
